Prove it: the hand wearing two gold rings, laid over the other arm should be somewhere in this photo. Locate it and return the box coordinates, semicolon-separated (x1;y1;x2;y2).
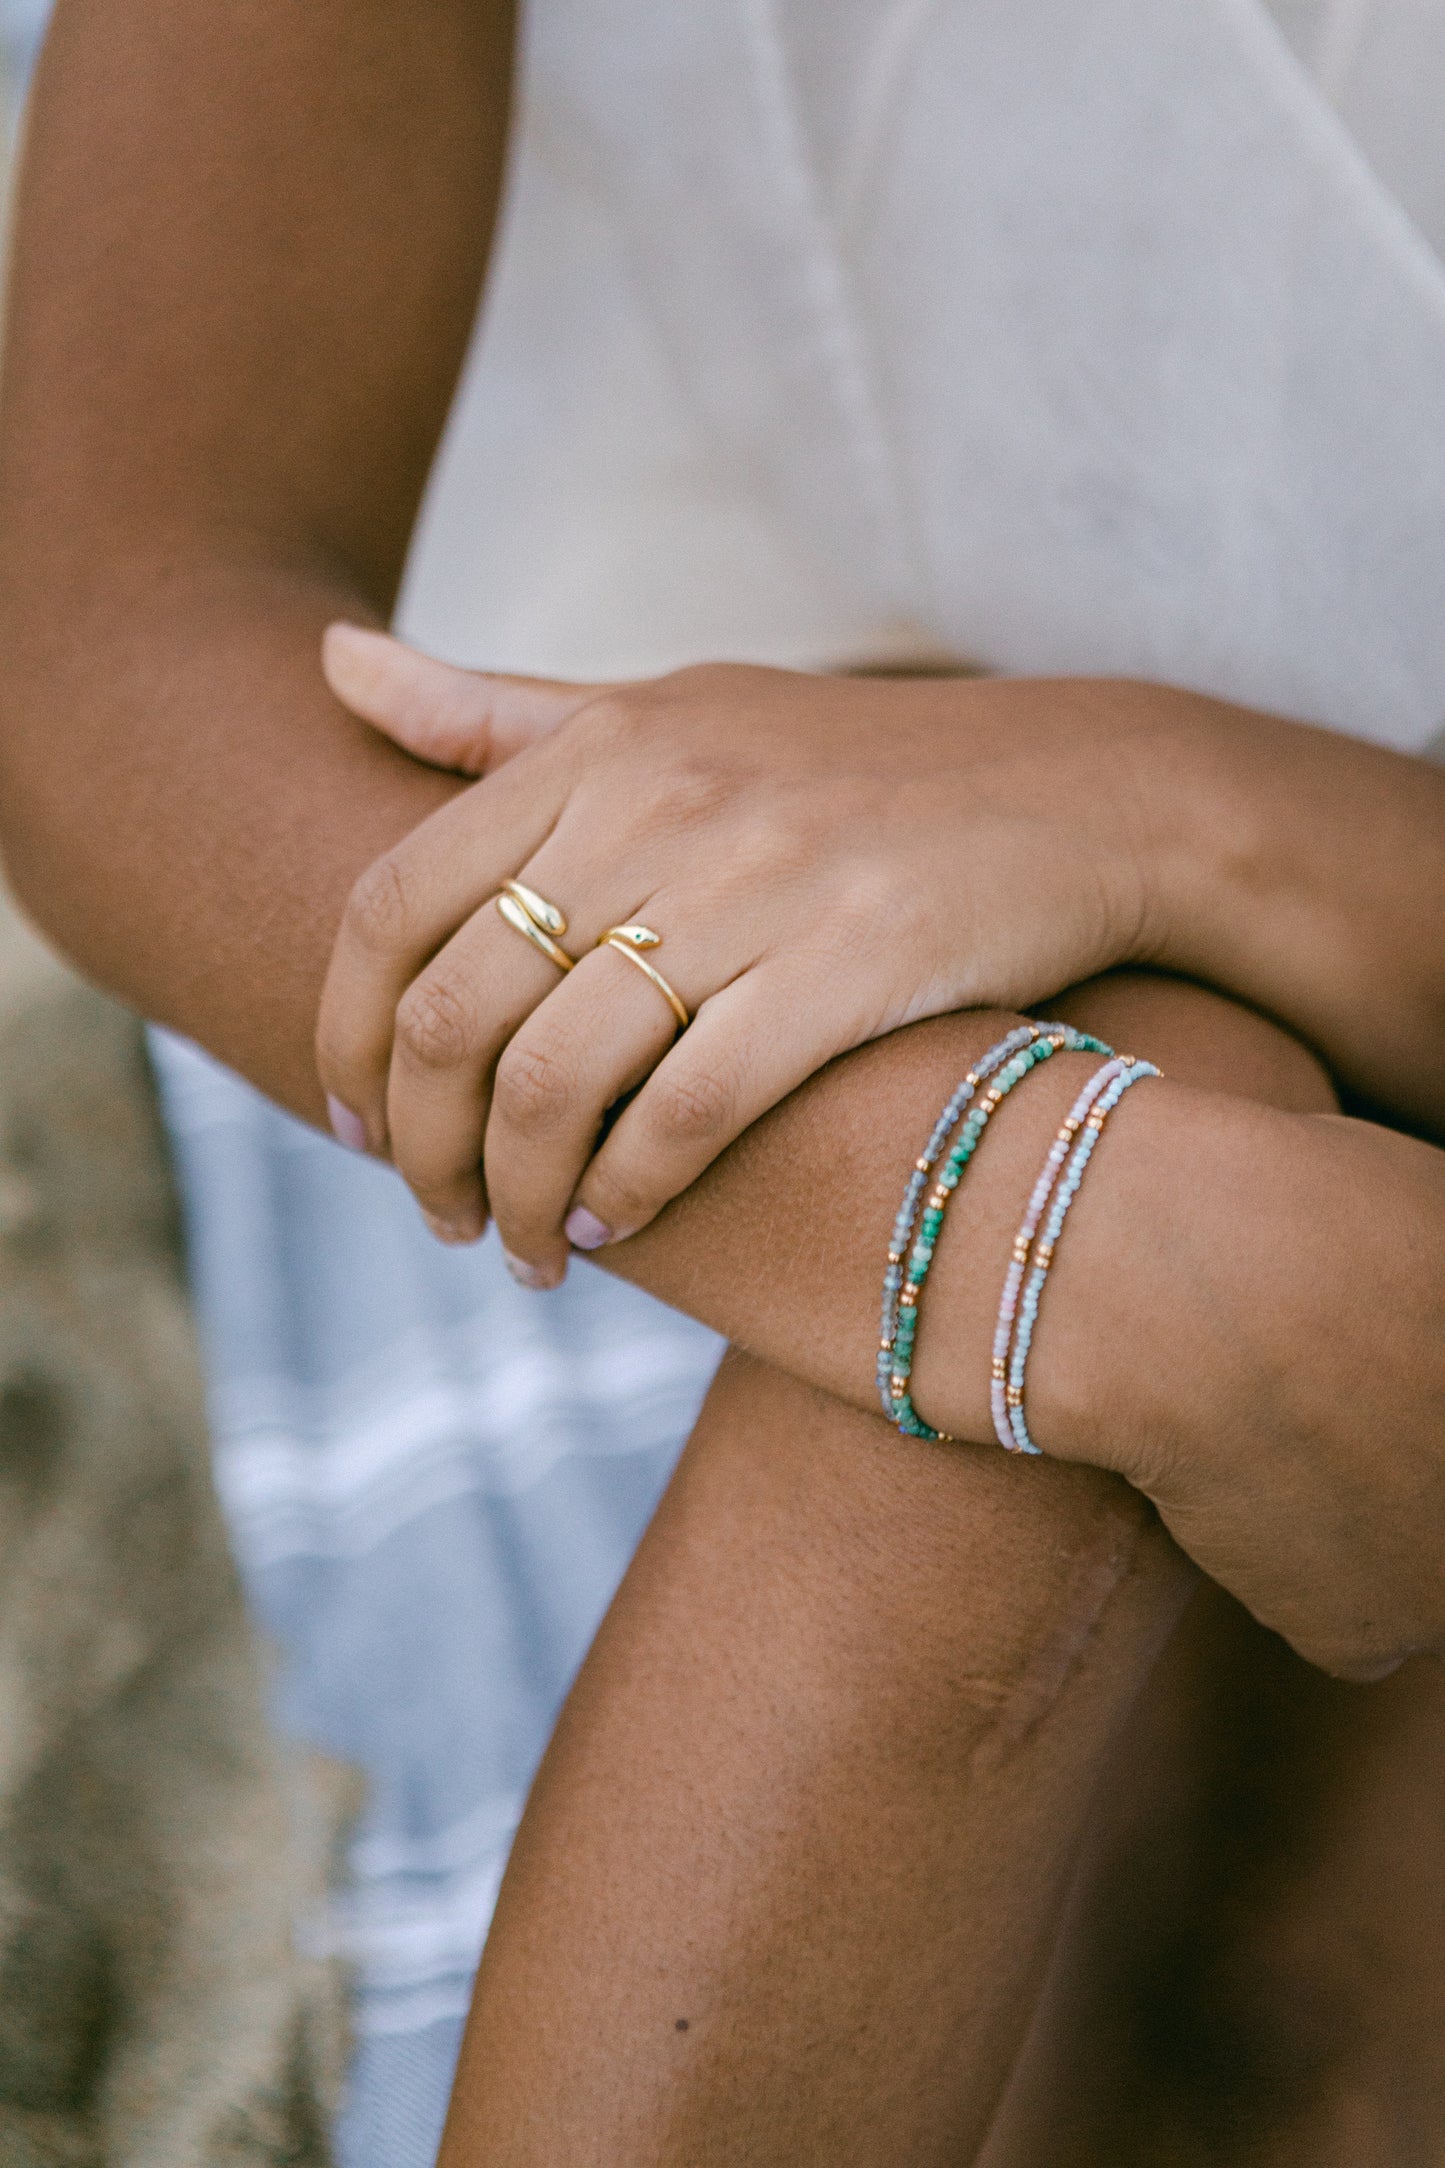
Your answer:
318;627;1187;1283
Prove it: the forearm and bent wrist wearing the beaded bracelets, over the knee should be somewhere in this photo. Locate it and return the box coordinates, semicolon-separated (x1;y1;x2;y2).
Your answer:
597;978;1445;1676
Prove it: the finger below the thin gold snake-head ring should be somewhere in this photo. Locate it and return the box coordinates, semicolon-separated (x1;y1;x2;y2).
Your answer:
485;947;680;1286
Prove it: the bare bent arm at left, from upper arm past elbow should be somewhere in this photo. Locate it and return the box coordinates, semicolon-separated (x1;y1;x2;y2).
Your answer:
0;0;511;1114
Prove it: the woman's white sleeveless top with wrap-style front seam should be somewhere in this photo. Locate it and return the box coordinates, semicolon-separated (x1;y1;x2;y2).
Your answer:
403;0;1445;763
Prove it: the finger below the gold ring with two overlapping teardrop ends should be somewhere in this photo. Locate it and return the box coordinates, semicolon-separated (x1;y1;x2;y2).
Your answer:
388;902;584;1242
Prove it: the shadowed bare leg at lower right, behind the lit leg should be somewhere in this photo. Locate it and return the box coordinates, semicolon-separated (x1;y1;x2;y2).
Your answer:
981;1587;1445;2168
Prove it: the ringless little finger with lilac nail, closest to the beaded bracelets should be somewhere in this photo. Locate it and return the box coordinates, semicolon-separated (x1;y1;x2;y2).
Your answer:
565;950;871;1249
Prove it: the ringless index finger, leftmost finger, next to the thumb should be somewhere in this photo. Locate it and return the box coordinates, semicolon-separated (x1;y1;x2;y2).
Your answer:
316;748;568;1151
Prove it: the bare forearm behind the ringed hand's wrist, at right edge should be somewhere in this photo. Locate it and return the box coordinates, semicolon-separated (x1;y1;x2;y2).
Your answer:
1127;687;1445;1136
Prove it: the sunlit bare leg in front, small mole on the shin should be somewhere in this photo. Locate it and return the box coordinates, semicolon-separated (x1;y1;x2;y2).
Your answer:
442;1355;1192;2168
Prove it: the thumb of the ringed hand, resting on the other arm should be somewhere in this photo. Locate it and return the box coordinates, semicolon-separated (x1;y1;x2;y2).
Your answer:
321;622;596;776
